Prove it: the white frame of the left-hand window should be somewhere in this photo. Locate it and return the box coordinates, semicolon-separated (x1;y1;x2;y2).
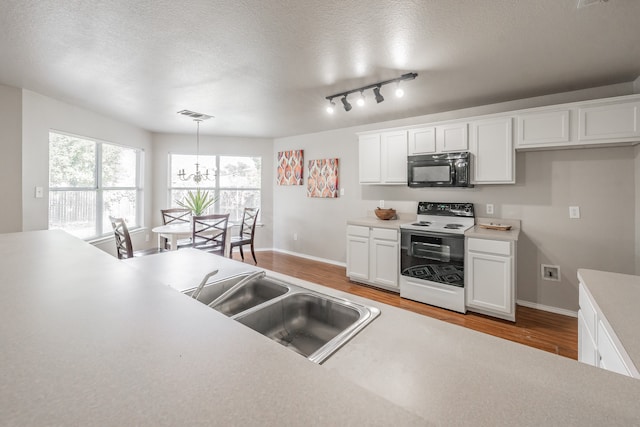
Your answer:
47;129;144;242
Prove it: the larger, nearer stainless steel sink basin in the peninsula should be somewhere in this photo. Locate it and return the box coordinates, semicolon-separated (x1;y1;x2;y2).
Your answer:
234;286;380;363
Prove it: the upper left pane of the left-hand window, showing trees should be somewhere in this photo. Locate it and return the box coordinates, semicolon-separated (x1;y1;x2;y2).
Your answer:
49;132;96;188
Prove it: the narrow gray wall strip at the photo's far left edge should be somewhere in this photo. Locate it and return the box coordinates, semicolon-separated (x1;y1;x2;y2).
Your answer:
0;85;22;233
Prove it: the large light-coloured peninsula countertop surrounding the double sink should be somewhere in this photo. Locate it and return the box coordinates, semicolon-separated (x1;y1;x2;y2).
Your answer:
0;231;640;426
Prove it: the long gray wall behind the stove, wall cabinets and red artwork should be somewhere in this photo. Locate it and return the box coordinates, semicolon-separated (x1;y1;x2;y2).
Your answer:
274;83;637;311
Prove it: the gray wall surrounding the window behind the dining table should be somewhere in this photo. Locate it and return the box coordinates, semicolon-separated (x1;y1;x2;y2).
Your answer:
153;134;274;249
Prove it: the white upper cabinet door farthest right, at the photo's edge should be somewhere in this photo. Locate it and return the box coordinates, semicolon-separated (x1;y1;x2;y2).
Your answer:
578;101;640;141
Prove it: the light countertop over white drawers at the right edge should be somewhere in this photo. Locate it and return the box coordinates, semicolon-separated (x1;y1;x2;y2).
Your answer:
578;268;640;369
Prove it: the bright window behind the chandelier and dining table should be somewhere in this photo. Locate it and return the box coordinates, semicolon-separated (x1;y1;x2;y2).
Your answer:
169;154;262;221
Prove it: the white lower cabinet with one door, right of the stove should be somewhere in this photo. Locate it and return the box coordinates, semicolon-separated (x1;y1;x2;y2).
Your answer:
465;238;516;321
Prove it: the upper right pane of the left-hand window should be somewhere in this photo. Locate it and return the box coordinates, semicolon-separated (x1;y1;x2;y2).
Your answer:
102;144;137;187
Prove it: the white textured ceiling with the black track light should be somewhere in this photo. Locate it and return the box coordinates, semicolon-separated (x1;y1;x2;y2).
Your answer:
0;0;640;137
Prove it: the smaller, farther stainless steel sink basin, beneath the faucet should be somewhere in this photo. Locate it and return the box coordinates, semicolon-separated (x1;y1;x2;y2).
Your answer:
210;277;290;317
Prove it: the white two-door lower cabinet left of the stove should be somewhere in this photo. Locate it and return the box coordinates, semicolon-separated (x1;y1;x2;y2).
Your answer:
347;225;400;291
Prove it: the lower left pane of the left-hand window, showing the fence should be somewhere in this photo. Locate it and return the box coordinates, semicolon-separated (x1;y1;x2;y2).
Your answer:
49;190;96;239
